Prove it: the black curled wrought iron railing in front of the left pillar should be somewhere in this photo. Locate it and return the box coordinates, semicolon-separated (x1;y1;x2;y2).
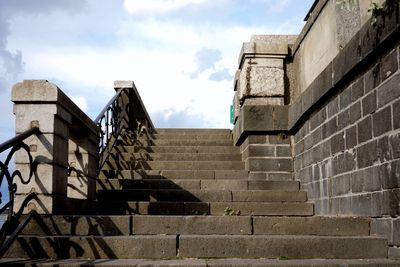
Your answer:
0;127;40;257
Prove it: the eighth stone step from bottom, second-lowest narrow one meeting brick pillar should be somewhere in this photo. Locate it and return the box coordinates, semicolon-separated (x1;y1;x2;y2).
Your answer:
103;160;245;170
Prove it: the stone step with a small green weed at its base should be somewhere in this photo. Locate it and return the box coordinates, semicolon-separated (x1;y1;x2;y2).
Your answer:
99;200;314;216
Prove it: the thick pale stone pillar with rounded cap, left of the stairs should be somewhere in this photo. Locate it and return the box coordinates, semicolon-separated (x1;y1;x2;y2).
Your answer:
12;80;98;214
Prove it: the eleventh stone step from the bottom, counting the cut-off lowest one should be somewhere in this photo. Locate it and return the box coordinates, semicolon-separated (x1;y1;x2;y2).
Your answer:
118;138;233;146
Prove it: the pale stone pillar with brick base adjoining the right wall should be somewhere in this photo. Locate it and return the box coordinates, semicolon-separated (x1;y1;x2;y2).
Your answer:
234;35;296;180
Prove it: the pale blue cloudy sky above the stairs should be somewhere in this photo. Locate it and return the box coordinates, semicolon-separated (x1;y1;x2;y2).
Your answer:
0;0;314;203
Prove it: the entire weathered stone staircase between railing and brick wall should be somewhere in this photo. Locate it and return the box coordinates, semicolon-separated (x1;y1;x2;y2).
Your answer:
0;129;400;266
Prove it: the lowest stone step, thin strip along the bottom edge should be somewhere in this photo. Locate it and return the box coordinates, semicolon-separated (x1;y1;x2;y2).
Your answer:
0;257;400;267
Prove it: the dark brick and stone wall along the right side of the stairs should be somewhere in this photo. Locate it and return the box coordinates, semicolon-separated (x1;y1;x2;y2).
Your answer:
234;0;400;253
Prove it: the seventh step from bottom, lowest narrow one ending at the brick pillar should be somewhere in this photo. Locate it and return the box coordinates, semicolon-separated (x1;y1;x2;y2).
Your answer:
99;170;247;180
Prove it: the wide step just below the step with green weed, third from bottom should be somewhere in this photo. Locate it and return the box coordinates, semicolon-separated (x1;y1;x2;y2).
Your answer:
16;215;370;236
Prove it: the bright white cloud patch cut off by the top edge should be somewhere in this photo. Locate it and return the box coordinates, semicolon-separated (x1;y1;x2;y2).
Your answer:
124;0;209;15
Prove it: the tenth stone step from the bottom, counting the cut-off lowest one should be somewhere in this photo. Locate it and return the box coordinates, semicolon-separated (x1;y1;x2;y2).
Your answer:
113;145;240;154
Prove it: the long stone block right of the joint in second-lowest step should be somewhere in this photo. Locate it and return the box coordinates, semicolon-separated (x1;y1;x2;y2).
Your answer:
179;235;387;259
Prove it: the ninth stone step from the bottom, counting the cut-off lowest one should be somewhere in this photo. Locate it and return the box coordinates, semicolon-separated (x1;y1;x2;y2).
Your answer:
113;152;242;161
